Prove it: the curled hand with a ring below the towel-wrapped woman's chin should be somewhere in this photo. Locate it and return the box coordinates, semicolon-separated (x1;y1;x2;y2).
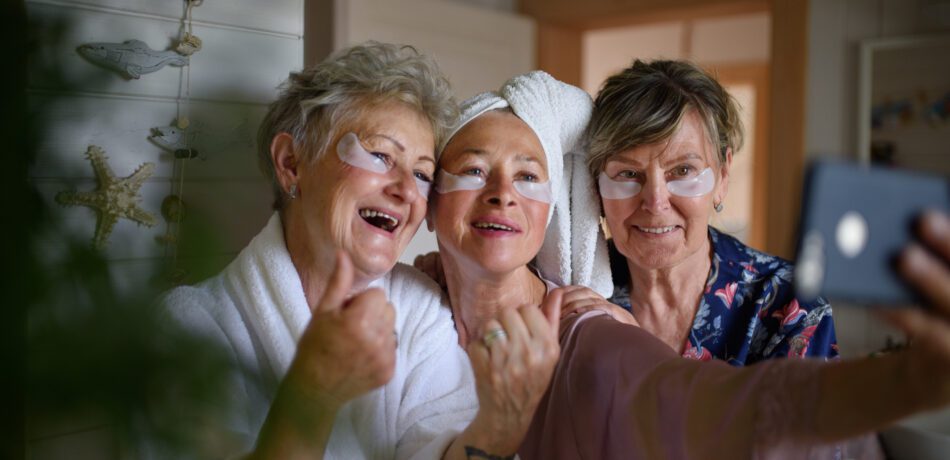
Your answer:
468;291;563;455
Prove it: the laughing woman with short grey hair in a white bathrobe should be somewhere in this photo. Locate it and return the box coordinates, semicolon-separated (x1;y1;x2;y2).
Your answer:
165;42;537;459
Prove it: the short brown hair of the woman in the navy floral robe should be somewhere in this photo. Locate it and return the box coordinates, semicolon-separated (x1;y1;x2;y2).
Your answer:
587;59;743;178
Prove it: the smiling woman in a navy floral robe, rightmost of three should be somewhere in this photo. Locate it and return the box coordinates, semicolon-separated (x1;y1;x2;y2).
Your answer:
588;60;838;366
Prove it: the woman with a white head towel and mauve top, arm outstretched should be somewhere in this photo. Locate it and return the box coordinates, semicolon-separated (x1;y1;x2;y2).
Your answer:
438;72;950;459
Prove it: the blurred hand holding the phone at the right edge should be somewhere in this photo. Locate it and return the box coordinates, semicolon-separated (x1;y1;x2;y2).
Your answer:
882;212;950;406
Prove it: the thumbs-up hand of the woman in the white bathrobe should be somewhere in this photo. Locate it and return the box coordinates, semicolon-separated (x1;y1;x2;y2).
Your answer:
285;251;396;408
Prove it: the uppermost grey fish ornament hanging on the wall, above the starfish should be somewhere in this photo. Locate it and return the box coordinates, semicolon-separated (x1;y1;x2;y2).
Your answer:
77;40;188;79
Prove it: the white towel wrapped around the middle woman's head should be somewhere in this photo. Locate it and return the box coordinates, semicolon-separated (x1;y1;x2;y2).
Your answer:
446;71;613;297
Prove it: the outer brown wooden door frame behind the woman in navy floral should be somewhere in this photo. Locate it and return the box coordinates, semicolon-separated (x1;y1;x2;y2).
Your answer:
521;0;808;258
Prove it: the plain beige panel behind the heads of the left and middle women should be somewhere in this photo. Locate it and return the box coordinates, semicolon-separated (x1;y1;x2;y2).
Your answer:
334;0;535;263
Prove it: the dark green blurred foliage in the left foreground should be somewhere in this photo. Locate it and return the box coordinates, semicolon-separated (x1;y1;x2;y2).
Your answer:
17;7;240;458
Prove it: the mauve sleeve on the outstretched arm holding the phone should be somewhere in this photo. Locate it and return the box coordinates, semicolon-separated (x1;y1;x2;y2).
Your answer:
519;312;875;459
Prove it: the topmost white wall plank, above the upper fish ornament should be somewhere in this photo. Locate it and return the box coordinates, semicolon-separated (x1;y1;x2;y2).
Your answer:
46;0;303;38
